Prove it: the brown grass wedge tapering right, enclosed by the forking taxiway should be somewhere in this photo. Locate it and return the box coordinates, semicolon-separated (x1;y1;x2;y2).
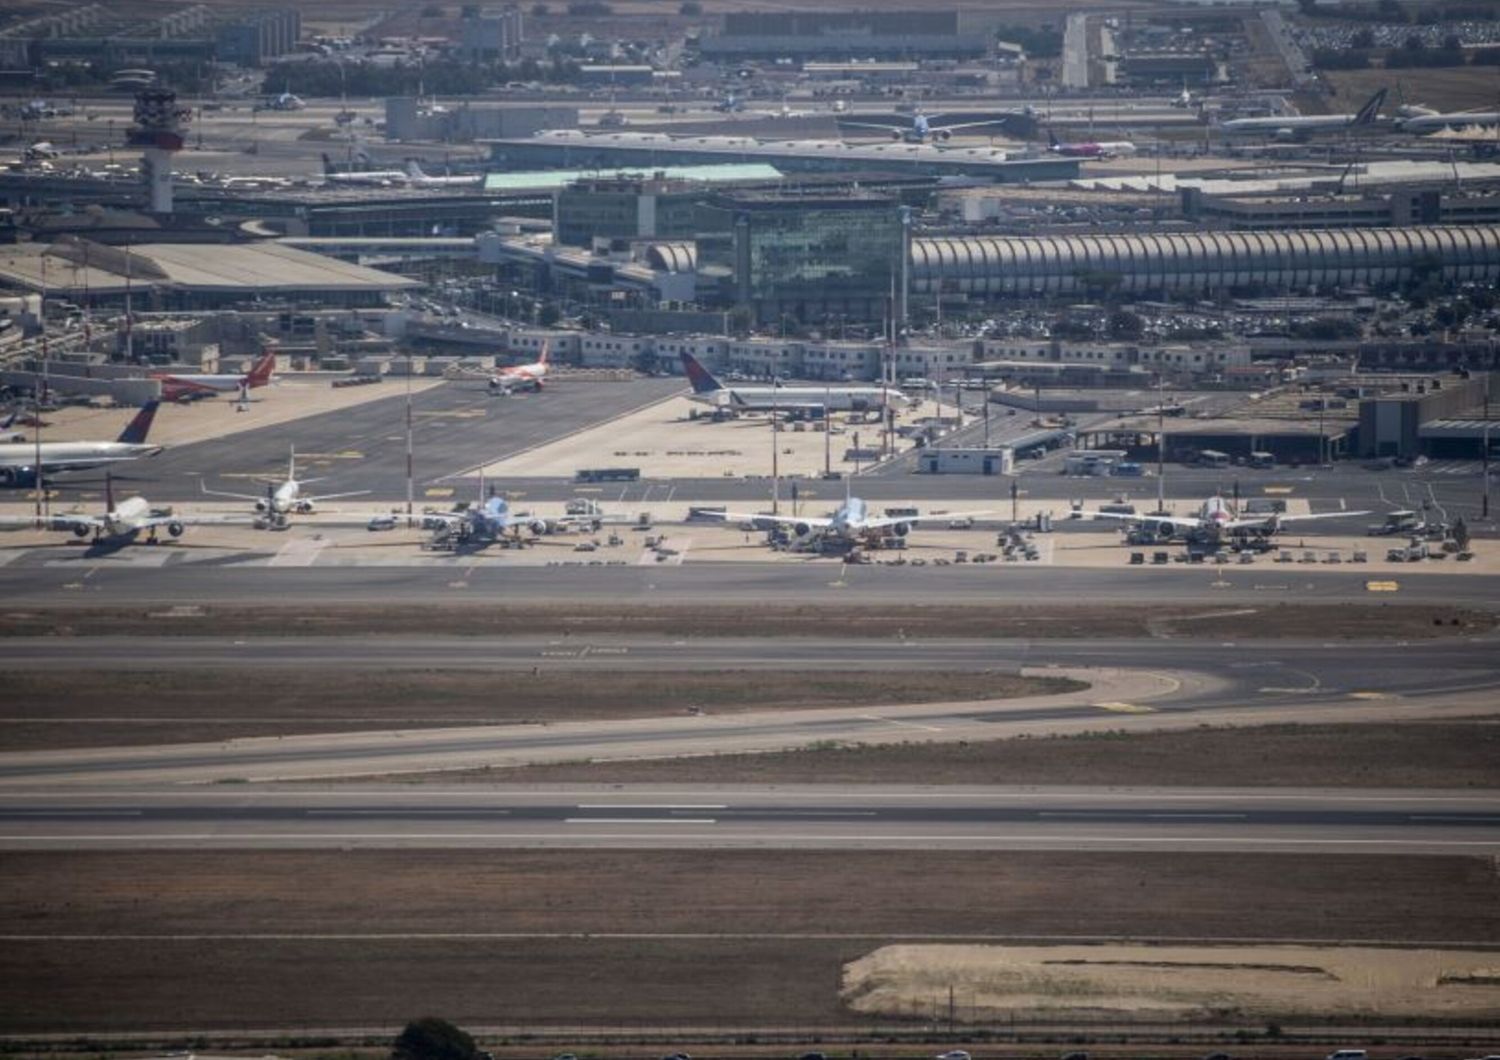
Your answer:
0;670;1083;751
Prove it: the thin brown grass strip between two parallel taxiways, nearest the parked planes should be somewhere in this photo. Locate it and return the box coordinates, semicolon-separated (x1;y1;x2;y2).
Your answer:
0;603;1497;640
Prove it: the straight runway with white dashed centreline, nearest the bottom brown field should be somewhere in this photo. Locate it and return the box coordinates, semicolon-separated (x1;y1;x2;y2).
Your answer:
0;786;1500;855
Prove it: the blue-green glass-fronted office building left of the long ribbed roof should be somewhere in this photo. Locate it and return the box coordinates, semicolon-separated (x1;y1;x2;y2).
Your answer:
698;192;903;324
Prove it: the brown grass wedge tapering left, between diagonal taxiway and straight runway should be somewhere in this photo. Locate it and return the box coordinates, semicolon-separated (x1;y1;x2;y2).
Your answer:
462;721;1500;789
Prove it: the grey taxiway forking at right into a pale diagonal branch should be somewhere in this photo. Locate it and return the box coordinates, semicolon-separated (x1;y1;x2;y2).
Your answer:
0;637;1500;790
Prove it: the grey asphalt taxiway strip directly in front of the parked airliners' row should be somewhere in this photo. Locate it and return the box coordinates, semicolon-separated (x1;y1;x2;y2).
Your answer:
0;563;1496;605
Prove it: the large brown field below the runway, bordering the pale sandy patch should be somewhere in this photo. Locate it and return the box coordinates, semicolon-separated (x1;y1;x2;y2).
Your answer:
0;850;1500;1033
